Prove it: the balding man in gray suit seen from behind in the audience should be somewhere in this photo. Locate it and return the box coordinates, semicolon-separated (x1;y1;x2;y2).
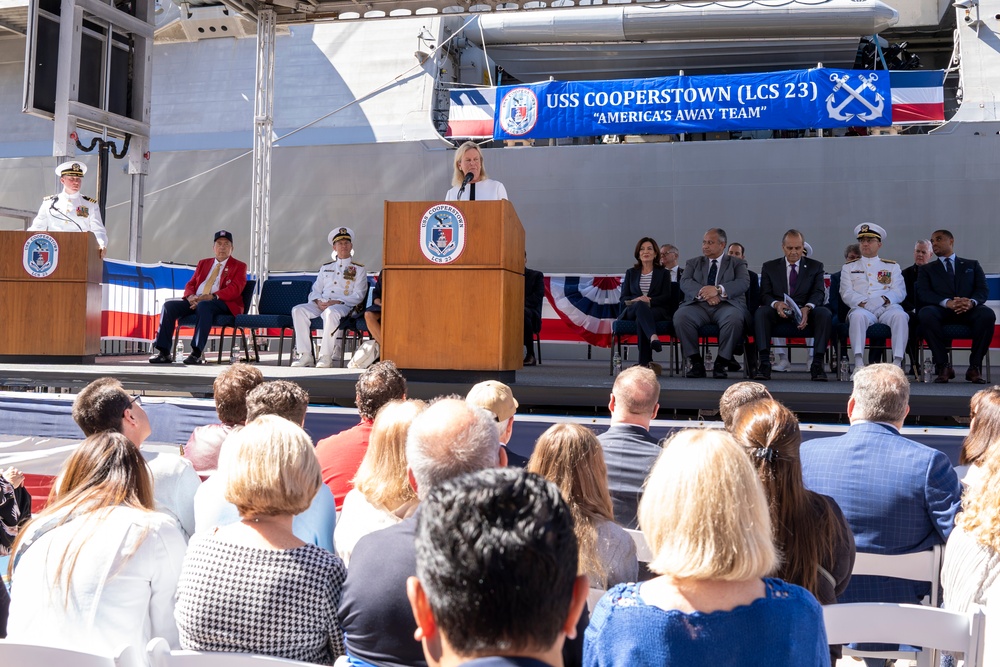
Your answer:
597;366;660;528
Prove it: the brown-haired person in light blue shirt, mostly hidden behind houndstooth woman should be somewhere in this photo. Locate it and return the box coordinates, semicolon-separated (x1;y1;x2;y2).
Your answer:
194;380;337;551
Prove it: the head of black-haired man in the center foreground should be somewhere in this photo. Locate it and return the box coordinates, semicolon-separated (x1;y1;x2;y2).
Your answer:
407;470;587;667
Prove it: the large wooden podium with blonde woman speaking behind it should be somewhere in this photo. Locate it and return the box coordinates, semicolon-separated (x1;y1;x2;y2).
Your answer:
381;200;524;380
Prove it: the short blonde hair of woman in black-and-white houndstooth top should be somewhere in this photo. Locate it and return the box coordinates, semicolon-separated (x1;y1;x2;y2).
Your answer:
226;415;323;519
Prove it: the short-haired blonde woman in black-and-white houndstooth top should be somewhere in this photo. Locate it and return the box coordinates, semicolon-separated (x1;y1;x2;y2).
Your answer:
175;415;346;665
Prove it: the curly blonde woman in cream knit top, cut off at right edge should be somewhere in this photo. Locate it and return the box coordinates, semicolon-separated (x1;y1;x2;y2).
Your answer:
941;412;1000;616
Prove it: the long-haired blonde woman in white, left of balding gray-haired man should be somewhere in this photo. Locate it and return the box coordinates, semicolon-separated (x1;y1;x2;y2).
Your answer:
334;401;427;565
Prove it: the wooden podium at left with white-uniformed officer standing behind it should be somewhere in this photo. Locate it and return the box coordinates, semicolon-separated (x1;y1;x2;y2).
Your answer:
0;231;104;364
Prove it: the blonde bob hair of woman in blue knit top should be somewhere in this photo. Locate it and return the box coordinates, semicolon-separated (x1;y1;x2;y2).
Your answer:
639;429;778;581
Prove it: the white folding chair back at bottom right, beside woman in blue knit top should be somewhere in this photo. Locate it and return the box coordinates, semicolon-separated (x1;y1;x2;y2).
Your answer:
823;602;986;667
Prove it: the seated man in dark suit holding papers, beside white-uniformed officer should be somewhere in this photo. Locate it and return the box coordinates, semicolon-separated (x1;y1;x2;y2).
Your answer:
754;229;832;382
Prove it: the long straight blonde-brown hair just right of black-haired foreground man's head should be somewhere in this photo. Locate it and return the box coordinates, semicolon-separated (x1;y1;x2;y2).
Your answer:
527;424;614;585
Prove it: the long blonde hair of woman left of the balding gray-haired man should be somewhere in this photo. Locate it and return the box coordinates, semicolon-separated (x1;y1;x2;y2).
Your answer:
351;401;427;512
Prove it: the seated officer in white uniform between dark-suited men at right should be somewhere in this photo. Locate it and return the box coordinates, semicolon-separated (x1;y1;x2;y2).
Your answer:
840;222;910;369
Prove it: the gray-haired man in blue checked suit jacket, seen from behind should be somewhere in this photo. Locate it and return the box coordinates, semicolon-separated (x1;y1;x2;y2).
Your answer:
801;364;962;604
